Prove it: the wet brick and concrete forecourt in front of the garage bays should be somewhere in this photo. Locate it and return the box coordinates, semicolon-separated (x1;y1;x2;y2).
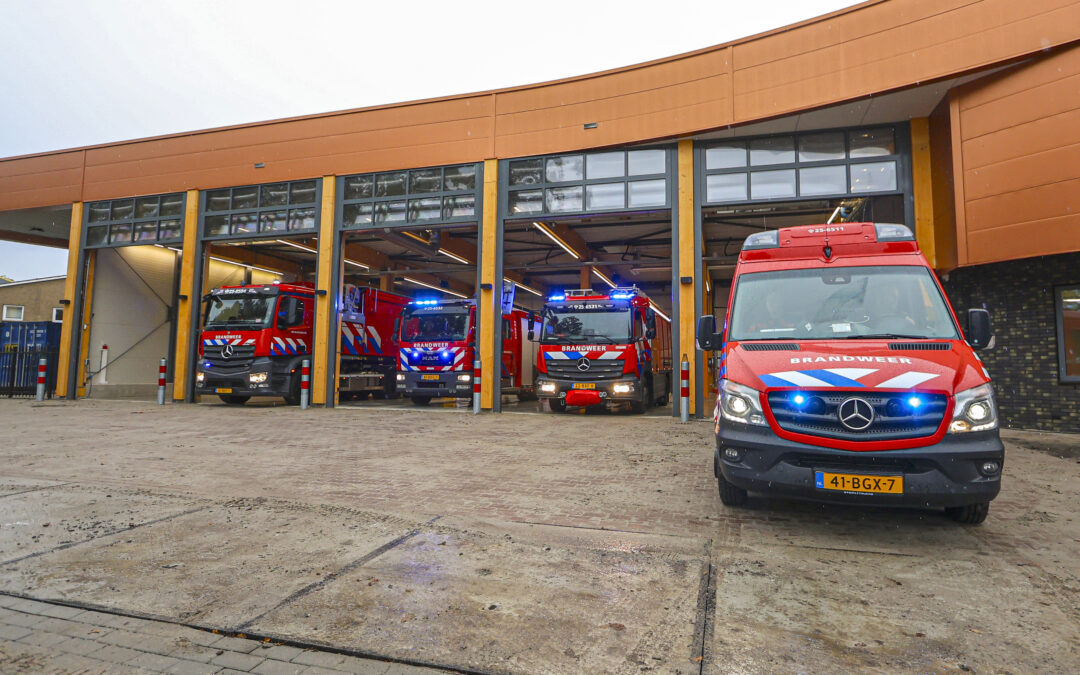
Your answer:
0;402;1080;674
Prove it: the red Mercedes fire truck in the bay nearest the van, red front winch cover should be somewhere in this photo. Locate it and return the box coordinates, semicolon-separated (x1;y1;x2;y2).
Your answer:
537;286;673;413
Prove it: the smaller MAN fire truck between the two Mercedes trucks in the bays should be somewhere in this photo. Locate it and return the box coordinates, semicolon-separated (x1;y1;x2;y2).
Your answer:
397;299;536;405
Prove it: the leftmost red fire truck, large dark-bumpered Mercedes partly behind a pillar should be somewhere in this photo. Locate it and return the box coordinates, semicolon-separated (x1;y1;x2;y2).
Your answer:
195;283;408;405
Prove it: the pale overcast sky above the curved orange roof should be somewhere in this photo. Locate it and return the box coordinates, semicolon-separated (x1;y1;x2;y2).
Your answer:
0;0;855;279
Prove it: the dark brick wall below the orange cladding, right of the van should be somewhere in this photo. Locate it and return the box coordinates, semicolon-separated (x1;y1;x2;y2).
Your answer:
942;253;1080;432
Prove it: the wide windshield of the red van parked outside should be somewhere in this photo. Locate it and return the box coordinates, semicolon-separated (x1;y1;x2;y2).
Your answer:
730;266;957;340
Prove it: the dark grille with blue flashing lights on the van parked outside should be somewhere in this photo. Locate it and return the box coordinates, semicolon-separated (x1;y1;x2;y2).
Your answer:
769;391;948;441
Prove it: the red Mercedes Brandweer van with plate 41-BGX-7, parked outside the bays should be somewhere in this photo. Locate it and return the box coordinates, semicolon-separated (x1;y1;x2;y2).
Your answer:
698;222;1004;524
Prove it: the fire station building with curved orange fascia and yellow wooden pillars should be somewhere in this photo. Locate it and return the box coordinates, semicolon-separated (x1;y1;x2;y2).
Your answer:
0;0;1080;431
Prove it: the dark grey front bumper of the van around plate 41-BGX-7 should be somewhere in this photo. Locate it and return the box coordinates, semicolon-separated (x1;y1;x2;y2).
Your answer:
716;424;1004;508
